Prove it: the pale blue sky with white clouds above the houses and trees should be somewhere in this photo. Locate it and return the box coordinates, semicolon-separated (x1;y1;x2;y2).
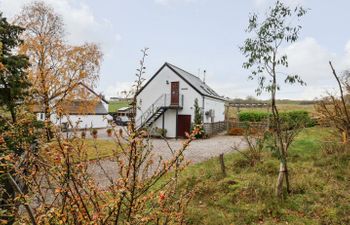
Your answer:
0;0;350;100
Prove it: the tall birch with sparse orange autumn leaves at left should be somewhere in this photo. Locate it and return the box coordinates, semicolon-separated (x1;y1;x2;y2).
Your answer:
16;1;102;139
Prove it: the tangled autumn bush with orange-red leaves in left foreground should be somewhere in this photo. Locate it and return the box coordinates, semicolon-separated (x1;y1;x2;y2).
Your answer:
0;38;200;224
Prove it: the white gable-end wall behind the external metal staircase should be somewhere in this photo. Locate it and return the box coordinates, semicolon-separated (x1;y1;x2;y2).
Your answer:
136;66;203;138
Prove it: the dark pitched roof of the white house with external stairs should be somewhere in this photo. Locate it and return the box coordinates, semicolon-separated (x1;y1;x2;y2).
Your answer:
138;62;225;101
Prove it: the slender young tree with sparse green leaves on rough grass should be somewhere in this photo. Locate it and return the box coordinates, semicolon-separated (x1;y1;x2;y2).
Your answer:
240;1;307;196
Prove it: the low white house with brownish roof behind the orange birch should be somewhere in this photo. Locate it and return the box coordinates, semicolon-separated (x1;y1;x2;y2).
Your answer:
33;83;112;129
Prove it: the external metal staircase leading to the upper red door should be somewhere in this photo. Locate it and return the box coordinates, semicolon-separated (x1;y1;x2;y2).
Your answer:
136;94;183;129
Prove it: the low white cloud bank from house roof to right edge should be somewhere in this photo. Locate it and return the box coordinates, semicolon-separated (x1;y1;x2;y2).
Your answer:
212;37;350;100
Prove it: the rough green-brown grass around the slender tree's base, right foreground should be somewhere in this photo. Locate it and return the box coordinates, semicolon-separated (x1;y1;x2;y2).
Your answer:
181;127;350;224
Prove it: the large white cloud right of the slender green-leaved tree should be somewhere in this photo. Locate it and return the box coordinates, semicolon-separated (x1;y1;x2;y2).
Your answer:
281;37;350;99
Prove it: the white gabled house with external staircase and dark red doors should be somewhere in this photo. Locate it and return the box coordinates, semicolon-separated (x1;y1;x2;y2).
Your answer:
136;63;225;138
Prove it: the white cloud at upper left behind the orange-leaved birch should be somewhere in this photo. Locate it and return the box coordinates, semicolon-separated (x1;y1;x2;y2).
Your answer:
0;0;121;52
